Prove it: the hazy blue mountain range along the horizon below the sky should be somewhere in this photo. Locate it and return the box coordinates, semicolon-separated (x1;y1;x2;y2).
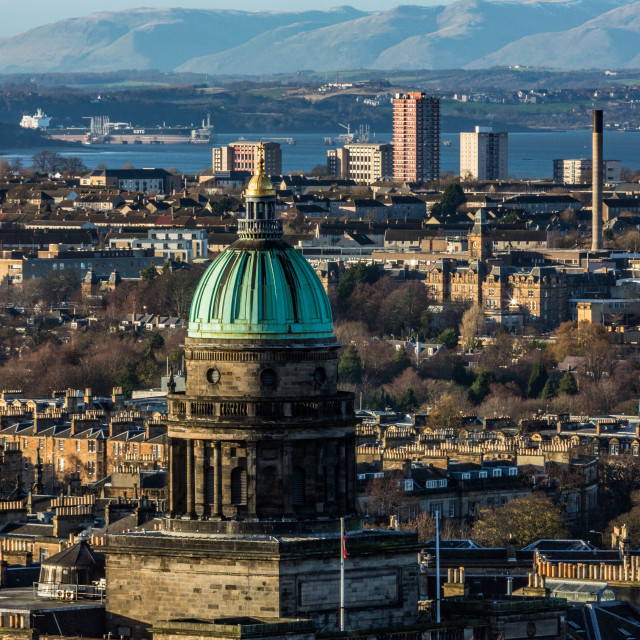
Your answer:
0;0;640;75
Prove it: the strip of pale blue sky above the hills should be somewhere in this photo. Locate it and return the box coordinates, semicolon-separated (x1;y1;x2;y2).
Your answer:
0;0;444;36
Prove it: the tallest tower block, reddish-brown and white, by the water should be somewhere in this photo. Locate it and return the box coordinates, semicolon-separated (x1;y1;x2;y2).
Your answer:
393;93;440;182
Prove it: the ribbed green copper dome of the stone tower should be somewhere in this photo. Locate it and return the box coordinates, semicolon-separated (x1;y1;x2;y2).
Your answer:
189;239;334;341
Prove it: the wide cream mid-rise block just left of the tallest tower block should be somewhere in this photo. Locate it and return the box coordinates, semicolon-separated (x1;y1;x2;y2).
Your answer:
327;143;393;182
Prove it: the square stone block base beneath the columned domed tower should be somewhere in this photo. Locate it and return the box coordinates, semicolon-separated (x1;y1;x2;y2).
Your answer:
102;532;418;637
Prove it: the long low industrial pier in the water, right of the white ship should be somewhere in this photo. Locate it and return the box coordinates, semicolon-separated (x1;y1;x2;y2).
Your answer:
44;116;215;145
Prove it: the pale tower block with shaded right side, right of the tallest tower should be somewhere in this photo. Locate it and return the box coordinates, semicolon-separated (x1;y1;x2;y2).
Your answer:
460;127;509;180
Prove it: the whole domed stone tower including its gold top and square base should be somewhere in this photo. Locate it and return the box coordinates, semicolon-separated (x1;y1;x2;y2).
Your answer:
101;148;418;638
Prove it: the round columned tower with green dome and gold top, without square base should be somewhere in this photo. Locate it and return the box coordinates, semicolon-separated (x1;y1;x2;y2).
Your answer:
169;146;355;531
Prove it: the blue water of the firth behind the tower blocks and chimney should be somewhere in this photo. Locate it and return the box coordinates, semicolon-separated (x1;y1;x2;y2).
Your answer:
5;131;640;179
